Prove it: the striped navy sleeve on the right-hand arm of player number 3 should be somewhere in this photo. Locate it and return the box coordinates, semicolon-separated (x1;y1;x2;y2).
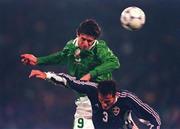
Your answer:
122;92;161;129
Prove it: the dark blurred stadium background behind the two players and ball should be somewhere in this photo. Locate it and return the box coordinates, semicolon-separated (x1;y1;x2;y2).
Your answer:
0;0;180;129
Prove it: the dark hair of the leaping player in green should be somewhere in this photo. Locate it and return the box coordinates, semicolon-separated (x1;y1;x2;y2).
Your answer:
76;19;101;39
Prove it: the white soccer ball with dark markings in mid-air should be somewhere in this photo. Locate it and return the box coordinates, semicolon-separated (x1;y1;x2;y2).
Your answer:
120;6;146;30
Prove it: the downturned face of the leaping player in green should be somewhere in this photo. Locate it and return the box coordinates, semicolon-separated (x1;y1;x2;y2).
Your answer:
77;34;95;50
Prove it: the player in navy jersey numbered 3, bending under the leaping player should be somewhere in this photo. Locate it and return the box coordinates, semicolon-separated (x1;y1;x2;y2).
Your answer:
29;70;161;129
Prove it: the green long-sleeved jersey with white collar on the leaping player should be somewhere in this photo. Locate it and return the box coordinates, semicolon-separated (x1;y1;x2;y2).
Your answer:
38;39;120;82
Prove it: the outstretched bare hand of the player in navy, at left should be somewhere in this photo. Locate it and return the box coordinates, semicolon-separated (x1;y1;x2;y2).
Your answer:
29;70;47;79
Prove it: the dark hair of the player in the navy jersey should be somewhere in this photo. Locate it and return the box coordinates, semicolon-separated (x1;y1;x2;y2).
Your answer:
98;80;116;96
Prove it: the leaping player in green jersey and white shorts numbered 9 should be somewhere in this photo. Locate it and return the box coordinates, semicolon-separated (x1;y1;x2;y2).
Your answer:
21;19;120;129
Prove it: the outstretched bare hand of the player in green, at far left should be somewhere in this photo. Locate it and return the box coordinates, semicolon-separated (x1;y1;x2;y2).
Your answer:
21;54;37;65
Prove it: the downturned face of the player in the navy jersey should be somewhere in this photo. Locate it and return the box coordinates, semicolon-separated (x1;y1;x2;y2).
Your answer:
98;93;115;110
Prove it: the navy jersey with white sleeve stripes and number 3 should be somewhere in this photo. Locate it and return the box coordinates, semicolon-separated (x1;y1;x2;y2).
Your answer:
46;73;161;129
